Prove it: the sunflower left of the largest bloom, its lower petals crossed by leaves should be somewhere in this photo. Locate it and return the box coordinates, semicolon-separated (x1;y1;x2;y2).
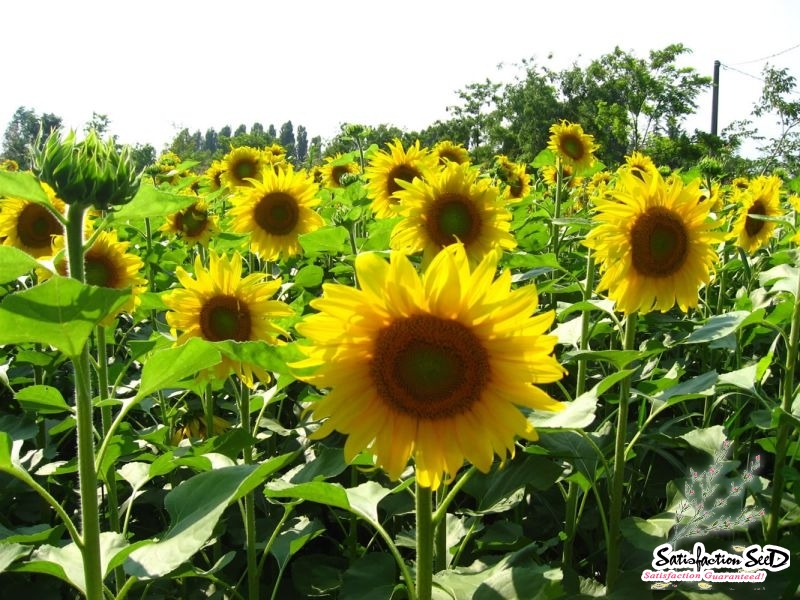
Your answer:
163;250;293;387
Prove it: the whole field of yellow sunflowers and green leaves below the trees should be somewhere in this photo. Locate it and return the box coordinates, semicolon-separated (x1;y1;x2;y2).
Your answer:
0;121;800;600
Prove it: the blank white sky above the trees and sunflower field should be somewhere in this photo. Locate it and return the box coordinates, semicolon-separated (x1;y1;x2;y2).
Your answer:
0;0;800;154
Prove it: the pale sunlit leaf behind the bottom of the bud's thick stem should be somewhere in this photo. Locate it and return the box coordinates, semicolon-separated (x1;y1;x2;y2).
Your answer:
21;531;128;594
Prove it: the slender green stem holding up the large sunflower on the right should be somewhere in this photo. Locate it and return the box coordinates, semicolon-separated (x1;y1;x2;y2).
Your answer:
606;312;638;592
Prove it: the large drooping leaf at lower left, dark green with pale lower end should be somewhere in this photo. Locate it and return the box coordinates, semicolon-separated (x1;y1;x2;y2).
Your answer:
124;455;291;579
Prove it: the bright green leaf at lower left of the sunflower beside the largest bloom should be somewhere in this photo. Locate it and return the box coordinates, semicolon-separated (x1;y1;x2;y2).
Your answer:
136;338;221;398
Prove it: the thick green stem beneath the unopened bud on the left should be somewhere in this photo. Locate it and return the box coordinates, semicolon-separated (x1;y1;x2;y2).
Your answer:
65;204;103;600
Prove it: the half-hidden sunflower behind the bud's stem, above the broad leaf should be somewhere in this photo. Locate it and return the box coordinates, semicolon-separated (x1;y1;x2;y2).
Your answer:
36;230;147;326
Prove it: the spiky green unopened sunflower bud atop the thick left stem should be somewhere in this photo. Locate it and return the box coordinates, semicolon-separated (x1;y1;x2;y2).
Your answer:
33;130;141;210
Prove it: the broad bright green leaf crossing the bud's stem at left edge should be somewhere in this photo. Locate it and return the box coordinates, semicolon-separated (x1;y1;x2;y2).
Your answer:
0;276;130;356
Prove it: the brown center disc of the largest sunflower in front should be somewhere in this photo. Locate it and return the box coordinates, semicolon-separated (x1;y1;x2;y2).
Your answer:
371;315;491;419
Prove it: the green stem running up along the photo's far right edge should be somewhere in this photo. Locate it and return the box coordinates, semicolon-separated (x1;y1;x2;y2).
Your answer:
766;258;800;544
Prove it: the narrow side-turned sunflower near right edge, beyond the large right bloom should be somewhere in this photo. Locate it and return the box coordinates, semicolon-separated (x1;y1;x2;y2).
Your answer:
732;175;783;253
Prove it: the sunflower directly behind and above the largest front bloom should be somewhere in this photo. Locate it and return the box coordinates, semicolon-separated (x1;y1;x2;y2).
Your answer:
391;163;517;264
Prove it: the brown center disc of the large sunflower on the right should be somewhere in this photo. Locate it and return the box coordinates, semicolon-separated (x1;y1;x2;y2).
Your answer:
631;206;689;277
